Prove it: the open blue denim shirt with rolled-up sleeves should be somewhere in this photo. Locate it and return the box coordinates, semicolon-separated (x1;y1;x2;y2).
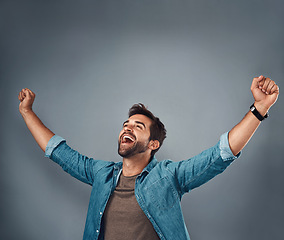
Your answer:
45;133;240;240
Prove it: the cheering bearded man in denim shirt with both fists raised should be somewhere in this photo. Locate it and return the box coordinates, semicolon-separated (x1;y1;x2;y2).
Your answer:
19;76;279;240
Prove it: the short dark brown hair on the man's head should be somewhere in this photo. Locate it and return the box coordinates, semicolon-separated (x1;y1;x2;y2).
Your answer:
128;103;167;156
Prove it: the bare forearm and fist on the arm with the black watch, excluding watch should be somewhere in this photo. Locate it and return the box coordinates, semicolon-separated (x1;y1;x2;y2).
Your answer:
229;76;279;155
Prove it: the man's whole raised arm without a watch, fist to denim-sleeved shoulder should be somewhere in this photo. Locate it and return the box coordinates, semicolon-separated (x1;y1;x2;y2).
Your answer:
18;88;110;185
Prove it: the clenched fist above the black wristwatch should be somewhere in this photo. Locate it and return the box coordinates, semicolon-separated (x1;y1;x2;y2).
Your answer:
251;75;279;111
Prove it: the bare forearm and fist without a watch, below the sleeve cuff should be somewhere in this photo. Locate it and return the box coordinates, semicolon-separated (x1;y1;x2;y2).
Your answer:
18;88;54;151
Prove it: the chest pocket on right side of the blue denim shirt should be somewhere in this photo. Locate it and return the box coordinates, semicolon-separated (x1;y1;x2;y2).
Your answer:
145;177;179;210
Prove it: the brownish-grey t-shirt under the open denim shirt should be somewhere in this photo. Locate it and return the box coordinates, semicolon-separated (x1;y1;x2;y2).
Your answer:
103;174;160;240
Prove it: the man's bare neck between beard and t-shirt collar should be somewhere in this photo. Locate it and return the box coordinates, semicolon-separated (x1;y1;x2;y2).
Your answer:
122;154;151;176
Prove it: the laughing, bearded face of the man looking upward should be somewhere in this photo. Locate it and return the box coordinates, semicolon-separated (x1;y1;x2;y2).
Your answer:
118;114;152;158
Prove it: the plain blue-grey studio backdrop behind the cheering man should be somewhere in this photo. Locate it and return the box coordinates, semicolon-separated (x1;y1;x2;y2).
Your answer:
0;0;284;240
